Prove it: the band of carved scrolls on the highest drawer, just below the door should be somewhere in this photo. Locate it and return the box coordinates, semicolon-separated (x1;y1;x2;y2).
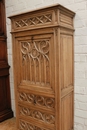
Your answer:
19;92;55;108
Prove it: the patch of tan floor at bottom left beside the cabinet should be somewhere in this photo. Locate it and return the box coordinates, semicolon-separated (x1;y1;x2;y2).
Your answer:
0;118;17;130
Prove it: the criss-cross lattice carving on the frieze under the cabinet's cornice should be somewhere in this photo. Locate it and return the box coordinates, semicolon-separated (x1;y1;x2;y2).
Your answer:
15;14;52;28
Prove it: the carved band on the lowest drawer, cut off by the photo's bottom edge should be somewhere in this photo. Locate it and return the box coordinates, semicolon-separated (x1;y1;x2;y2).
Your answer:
19;120;48;130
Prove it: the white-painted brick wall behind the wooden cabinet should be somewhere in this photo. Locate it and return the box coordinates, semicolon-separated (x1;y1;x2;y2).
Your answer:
5;0;87;130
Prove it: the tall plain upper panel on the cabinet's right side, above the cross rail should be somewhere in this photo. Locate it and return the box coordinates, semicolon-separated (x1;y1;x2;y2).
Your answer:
60;34;73;89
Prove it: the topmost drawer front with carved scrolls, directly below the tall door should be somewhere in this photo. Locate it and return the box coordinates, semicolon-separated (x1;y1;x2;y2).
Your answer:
18;92;55;111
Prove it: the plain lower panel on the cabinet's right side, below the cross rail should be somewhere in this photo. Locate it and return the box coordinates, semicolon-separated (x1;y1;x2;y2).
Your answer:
61;92;73;130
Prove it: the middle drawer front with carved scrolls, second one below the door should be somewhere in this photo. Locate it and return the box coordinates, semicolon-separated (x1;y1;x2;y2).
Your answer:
19;105;55;126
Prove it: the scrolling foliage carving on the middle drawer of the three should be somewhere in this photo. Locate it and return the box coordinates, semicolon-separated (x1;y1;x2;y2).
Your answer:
19;106;55;124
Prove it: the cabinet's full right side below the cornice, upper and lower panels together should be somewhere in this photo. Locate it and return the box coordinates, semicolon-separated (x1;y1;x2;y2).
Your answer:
60;30;74;130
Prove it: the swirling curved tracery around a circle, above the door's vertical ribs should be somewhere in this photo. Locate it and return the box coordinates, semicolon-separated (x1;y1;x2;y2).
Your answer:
21;40;49;61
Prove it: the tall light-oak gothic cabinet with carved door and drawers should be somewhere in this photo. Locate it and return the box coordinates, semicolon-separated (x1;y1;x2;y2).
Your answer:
10;5;75;130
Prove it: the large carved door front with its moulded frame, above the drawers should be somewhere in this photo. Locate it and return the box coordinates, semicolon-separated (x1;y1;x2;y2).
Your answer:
15;33;54;90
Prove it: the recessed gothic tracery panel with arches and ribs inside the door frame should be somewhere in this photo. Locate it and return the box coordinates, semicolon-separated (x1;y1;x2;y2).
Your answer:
21;39;50;86
